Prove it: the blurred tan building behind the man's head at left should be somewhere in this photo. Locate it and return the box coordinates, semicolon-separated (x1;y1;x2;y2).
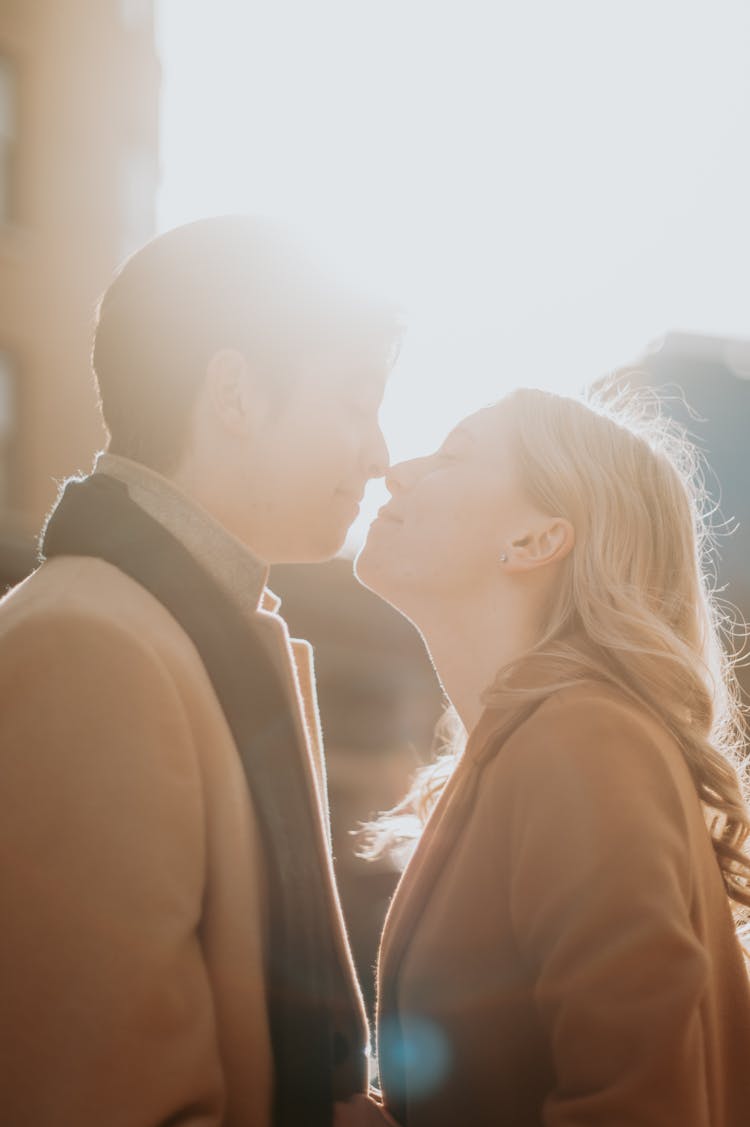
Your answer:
0;0;160;549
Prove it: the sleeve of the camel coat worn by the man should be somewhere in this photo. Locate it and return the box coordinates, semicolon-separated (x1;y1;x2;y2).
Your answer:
0;615;231;1127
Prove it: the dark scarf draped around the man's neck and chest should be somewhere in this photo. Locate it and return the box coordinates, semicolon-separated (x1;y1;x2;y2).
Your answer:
42;473;364;1127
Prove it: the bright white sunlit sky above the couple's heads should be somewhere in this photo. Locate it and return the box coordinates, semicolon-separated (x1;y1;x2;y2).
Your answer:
158;0;750;543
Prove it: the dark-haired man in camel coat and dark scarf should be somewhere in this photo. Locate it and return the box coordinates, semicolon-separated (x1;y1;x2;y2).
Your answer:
0;216;398;1127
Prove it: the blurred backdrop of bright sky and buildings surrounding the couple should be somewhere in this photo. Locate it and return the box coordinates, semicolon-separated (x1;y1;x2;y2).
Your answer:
0;0;750;1018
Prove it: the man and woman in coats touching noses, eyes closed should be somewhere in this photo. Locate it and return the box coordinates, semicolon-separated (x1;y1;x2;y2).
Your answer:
0;218;750;1127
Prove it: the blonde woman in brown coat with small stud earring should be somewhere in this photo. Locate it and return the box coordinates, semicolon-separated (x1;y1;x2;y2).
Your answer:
338;390;750;1127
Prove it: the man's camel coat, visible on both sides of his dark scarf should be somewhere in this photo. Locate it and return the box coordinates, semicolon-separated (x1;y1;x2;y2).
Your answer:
0;459;363;1127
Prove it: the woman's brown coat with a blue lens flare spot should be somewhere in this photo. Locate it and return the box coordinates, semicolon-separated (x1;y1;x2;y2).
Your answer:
379;683;750;1127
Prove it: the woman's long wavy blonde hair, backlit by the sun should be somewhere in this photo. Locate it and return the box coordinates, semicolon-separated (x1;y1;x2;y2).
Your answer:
363;373;750;919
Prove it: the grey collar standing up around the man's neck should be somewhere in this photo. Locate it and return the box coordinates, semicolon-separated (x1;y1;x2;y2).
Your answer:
94;452;271;614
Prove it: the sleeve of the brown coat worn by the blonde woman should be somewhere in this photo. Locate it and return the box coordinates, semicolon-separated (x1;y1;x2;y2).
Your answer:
510;701;709;1127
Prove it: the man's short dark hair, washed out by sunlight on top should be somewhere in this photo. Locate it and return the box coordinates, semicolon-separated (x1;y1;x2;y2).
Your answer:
91;215;402;472
